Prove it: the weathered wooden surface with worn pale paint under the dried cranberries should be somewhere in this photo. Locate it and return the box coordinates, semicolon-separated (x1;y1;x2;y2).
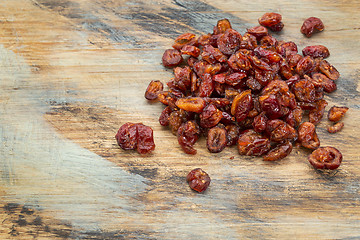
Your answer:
0;0;360;239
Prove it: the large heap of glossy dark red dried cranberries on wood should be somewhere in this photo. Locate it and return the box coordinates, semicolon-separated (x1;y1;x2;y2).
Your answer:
145;13;347;174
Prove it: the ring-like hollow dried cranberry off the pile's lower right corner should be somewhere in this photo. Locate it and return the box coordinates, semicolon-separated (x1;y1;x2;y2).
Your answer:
308;147;342;170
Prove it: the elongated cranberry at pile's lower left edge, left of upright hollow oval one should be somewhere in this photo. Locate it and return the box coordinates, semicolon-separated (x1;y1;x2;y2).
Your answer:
177;120;200;154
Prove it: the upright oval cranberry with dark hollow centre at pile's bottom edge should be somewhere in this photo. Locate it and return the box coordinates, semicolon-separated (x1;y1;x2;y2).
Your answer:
206;127;227;153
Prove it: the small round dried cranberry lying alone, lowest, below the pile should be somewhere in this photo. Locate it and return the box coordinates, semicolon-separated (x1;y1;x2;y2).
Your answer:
186;168;211;192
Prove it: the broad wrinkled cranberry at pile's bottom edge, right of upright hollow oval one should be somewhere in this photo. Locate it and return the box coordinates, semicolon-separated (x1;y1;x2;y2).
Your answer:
238;129;270;156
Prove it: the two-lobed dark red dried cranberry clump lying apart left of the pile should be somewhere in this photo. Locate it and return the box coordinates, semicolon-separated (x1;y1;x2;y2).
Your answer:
115;122;155;154
